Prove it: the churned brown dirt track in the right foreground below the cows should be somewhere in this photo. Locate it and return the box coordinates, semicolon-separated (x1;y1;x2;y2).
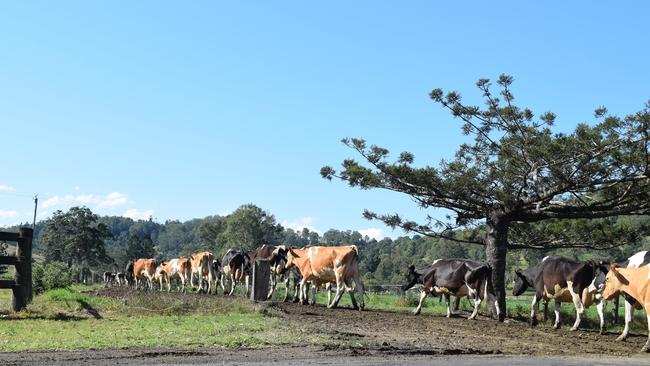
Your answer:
268;304;650;362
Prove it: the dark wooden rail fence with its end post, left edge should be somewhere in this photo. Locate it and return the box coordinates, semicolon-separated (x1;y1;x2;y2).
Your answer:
0;228;34;311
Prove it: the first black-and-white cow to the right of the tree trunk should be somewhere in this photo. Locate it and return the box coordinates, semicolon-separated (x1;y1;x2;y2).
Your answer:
521;256;608;334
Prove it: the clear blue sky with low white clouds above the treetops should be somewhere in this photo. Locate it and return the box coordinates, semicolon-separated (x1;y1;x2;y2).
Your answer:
0;1;650;236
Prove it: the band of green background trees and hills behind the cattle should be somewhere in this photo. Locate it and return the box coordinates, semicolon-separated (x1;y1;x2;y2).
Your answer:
2;204;650;286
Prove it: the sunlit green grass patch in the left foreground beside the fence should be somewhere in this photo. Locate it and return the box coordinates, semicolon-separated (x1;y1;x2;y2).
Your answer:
0;286;327;352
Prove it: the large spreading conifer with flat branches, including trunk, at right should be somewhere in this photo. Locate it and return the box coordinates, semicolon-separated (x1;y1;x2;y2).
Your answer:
321;75;650;321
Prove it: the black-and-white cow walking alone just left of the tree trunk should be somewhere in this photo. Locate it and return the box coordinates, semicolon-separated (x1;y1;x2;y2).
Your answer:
402;258;499;320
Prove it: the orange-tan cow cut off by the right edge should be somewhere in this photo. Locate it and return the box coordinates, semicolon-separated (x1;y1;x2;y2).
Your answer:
603;263;650;352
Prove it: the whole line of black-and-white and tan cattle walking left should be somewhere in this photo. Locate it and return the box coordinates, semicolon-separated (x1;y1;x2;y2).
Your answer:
104;245;650;351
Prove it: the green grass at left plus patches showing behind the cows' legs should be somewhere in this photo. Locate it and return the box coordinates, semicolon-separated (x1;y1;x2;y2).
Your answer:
0;285;645;352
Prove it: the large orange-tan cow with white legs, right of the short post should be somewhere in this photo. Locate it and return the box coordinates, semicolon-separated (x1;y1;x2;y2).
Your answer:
286;245;365;310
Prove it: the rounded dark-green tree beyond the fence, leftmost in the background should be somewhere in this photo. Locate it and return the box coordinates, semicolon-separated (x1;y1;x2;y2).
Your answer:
40;207;112;268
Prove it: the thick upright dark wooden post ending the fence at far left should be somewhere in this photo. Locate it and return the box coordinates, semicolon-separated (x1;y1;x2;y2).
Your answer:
11;228;34;311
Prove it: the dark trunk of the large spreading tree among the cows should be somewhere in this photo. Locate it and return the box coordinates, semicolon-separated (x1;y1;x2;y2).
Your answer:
485;214;510;322
